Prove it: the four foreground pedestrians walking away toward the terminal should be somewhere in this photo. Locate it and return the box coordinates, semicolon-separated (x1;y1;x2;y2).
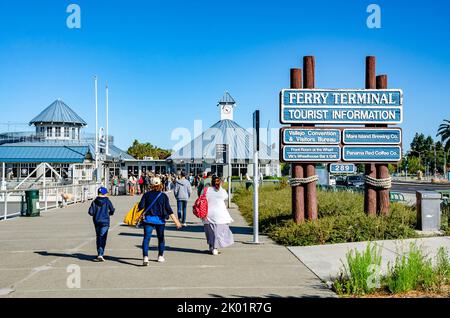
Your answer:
88;172;234;266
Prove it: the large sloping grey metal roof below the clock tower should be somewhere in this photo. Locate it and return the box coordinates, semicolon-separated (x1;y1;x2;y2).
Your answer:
168;119;279;163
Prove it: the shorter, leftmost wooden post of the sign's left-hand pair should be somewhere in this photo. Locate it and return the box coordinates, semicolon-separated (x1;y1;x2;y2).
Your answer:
291;68;305;224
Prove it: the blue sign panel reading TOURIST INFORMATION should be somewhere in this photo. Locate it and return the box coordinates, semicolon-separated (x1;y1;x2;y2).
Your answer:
281;107;403;125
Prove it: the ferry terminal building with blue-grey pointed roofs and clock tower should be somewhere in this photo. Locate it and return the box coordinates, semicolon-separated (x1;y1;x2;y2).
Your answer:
0;93;280;189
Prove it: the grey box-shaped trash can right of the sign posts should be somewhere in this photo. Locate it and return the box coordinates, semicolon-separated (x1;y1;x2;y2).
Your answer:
416;191;442;231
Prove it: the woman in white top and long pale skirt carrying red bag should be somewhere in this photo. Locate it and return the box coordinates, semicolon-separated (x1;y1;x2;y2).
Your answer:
203;176;234;255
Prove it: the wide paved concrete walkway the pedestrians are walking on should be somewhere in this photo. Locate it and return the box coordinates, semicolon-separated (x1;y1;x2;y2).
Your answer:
0;193;335;298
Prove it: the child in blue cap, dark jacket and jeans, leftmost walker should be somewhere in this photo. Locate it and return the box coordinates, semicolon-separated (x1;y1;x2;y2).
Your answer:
88;187;115;262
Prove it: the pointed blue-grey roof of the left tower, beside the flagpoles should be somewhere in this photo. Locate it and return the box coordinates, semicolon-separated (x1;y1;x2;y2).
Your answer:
30;99;87;126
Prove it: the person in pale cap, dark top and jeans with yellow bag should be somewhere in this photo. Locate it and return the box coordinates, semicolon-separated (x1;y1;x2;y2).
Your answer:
138;178;181;266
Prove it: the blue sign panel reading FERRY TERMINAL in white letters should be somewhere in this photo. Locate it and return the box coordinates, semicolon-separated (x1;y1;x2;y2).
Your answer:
281;89;403;107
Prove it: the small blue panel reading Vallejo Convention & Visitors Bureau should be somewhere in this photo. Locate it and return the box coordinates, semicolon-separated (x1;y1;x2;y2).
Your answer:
282;128;341;145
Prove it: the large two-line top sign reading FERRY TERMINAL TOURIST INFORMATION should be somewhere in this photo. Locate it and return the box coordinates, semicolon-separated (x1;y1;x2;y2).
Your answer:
280;89;403;125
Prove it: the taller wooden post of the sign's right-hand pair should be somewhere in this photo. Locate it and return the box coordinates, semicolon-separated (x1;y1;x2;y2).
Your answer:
364;56;377;215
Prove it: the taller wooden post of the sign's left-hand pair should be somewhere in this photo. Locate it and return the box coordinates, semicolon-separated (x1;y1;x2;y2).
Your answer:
303;56;318;220
